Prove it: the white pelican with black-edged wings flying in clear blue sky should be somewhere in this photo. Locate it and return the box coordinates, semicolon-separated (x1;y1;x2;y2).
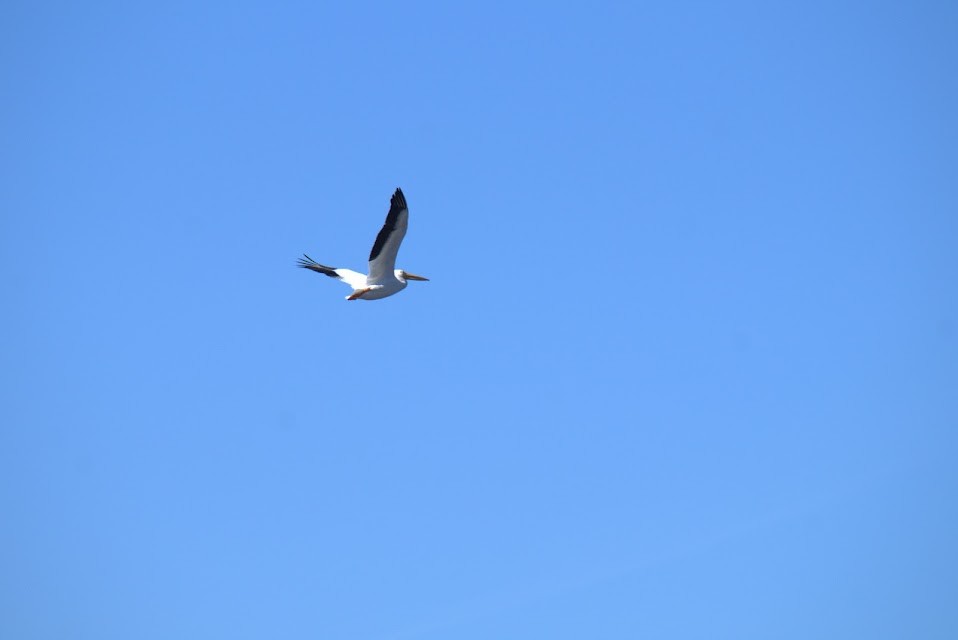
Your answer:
299;189;429;300
